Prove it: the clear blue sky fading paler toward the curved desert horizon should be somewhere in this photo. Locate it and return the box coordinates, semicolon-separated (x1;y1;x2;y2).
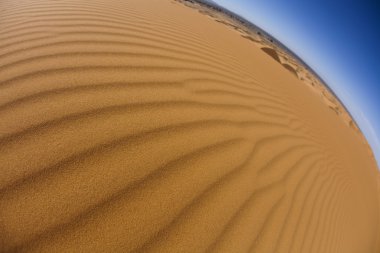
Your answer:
214;0;380;167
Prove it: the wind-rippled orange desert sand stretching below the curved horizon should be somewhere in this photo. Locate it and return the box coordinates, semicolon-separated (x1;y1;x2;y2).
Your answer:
0;0;380;253
